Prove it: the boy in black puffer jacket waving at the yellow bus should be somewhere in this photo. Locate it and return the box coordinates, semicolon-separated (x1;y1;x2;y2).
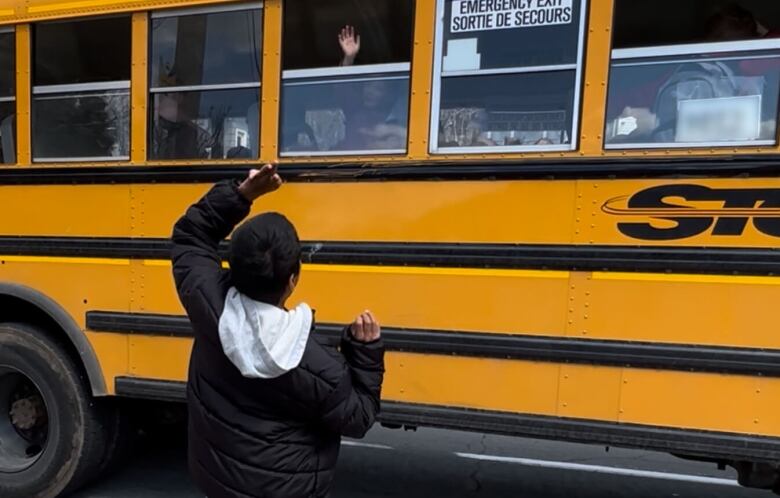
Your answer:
173;165;384;498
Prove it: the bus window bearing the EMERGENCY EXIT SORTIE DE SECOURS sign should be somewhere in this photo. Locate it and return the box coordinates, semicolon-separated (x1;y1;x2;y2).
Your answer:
431;0;586;153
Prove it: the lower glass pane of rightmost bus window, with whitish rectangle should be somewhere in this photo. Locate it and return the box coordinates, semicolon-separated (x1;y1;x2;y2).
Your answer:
605;53;780;147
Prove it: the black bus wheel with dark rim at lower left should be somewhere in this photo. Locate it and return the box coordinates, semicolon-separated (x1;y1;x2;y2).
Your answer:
0;323;108;498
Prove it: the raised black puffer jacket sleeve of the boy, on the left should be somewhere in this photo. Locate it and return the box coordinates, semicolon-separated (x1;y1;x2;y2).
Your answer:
171;181;251;322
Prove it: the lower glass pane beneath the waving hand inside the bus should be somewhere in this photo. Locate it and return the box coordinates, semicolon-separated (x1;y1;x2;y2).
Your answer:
281;76;409;152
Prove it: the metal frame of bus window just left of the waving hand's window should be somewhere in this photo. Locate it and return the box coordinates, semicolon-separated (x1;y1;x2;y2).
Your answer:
145;0;266;164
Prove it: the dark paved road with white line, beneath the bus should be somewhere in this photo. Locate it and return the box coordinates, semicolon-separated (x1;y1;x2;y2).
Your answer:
76;428;773;498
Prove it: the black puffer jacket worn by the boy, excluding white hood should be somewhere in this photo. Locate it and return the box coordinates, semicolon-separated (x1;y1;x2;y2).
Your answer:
173;182;384;498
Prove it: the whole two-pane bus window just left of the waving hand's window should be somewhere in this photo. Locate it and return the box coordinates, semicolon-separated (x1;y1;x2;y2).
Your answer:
149;4;263;159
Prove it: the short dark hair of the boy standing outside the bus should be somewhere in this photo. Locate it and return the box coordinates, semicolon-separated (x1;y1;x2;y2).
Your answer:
229;213;301;305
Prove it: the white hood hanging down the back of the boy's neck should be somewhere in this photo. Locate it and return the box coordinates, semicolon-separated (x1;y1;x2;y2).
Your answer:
219;287;312;379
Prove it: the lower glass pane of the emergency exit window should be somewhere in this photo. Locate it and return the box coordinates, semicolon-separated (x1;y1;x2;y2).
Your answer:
439;71;575;148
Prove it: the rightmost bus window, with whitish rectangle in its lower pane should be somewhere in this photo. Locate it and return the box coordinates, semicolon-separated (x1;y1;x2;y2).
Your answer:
604;0;780;149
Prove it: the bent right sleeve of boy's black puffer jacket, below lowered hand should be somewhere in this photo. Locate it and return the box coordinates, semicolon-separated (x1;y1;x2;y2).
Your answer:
322;332;385;438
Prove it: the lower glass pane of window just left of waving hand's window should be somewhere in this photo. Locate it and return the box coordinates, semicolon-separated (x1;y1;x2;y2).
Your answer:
149;88;260;159
